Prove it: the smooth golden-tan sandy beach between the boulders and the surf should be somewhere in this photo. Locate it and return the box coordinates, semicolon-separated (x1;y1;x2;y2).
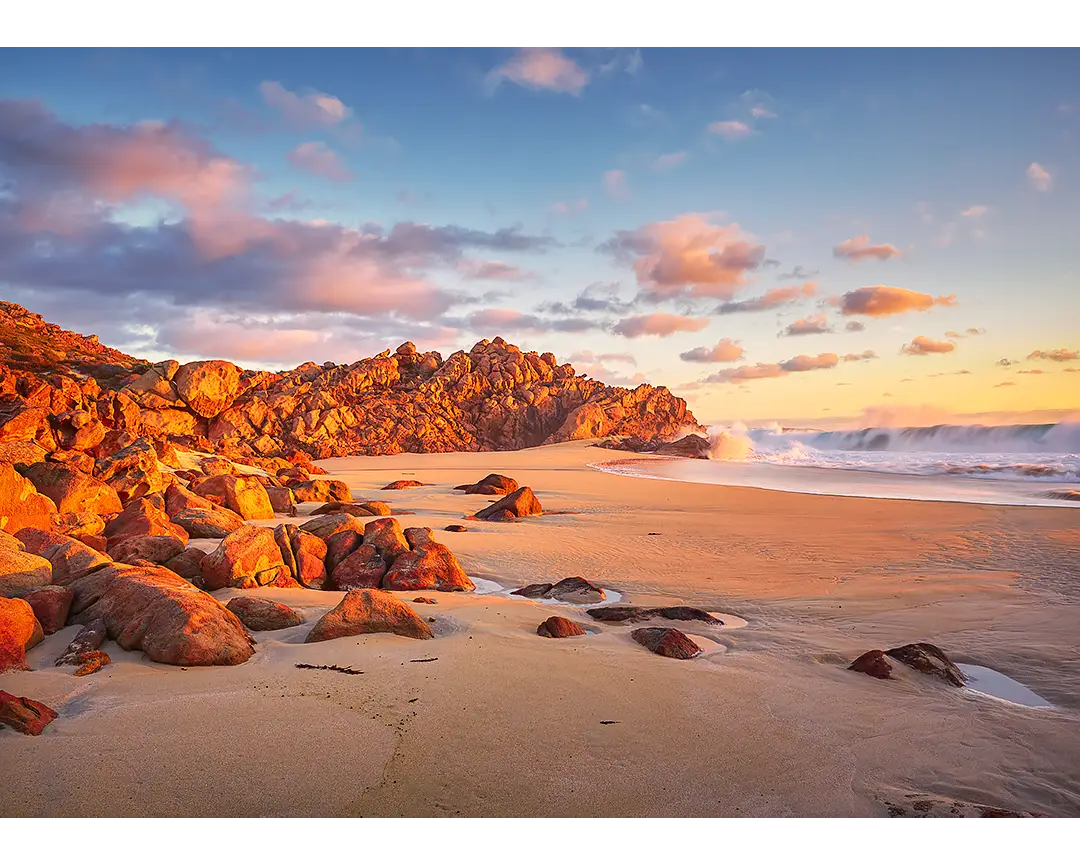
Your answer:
0;443;1080;820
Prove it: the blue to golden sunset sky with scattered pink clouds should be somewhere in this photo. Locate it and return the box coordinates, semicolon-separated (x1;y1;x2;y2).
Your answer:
0;44;1080;426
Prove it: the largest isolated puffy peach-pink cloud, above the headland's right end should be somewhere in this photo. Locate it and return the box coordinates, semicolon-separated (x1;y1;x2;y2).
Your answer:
599;213;765;302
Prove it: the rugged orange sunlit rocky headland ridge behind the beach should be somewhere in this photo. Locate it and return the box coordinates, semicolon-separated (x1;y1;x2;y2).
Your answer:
0;303;700;460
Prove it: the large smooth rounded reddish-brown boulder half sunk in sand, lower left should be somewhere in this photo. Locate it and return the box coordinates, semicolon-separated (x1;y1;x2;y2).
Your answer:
75;561;257;666
